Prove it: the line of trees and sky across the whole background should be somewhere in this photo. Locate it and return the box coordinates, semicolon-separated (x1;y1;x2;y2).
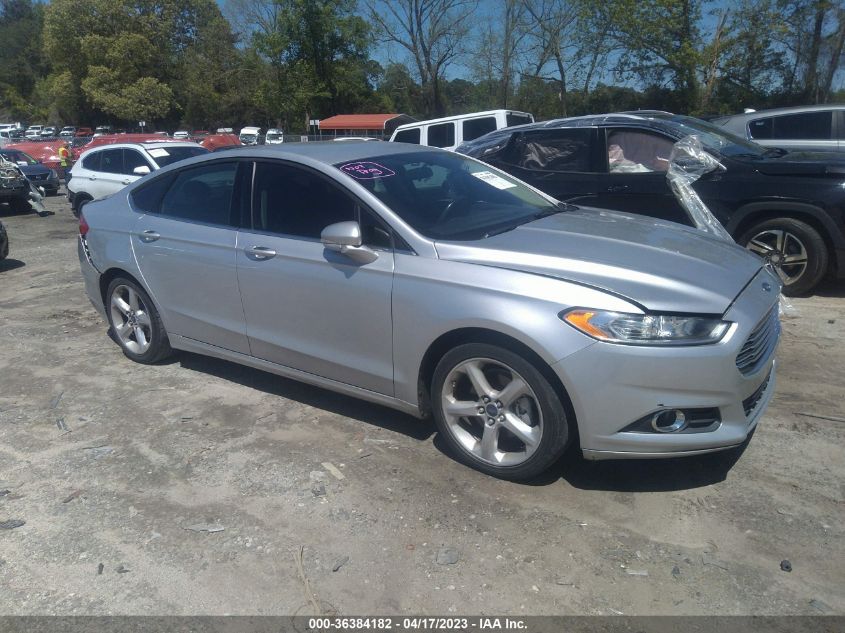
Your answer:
0;0;845;133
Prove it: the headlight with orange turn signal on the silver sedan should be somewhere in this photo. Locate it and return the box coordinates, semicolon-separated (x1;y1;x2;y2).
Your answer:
560;308;731;345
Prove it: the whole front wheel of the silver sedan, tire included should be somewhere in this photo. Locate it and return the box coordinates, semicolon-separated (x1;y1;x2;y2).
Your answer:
431;343;569;480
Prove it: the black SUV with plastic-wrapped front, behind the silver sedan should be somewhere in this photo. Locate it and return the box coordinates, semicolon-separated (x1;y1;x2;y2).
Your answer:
457;112;845;295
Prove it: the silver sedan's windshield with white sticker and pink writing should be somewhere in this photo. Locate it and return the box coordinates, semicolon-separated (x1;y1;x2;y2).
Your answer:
335;151;565;240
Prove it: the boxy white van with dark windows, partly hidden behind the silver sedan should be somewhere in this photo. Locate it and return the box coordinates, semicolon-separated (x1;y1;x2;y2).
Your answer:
390;110;534;150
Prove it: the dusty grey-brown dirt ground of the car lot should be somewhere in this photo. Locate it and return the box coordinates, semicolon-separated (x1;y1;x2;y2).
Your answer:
0;198;845;615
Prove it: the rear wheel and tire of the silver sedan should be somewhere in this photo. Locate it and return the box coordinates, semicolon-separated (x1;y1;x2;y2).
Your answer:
106;277;172;364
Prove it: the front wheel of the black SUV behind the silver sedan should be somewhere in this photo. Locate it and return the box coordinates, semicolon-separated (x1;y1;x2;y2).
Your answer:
739;218;828;297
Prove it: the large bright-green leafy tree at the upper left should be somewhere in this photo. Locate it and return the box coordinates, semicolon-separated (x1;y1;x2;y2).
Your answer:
44;0;234;123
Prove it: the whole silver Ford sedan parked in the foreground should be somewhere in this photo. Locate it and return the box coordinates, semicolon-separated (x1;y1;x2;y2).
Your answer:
79;142;780;479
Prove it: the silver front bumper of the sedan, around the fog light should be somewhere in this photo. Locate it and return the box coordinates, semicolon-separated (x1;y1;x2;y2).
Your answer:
553;270;778;459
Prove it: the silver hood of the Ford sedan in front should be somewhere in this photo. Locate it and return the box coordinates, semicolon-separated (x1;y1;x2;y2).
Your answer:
436;207;763;315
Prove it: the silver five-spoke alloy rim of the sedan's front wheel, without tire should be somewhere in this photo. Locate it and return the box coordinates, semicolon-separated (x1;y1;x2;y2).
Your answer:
441;358;543;466
